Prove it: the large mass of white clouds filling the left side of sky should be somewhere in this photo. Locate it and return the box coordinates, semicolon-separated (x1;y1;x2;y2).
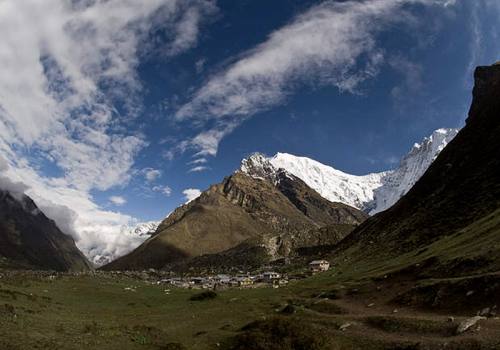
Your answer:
0;0;215;266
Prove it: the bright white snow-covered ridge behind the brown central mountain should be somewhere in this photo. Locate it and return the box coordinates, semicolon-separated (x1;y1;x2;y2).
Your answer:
240;129;458;215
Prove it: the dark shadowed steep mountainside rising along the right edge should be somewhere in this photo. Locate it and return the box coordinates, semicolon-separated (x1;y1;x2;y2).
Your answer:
334;65;500;276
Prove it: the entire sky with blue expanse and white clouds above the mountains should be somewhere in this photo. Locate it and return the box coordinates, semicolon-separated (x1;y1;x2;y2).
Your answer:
0;0;500;259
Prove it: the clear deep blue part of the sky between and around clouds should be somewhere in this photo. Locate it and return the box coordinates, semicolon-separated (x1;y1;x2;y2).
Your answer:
112;0;495;219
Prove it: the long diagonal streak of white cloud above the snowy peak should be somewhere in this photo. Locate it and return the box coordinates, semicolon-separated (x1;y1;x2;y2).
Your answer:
176;0;453;156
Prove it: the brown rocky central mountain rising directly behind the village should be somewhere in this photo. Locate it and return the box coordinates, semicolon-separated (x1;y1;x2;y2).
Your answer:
104;167;367;270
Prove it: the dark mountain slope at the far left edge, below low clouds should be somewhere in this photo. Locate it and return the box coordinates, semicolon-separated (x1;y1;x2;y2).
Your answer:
0;190;91;271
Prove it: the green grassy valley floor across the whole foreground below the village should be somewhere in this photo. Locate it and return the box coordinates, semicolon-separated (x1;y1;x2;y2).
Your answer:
0;271;500;350
